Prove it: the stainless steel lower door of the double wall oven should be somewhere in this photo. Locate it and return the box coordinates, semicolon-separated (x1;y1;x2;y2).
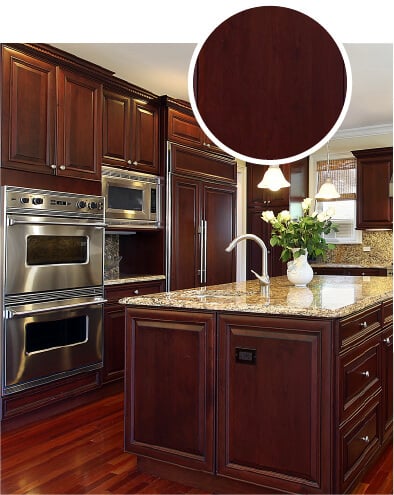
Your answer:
3;297;104;395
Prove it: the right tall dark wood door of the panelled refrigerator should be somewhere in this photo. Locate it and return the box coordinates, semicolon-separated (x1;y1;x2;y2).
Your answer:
202;182;237;285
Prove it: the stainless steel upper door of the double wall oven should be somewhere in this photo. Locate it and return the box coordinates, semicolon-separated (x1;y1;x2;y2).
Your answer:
5;215;104;295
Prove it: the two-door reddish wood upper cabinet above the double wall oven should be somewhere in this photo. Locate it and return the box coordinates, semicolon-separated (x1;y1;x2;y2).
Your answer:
2;46;102;180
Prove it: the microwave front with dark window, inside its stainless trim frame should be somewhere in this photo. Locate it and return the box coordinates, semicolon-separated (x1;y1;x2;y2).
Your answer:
103;176;156;221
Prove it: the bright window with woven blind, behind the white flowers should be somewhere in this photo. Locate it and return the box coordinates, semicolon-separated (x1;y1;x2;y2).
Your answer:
316;158;362;244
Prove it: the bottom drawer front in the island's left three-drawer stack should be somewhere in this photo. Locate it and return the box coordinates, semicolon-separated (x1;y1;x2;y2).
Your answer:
337;396;380;493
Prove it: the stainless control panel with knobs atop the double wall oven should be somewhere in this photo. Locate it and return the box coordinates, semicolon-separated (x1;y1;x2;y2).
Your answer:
6;187;104;216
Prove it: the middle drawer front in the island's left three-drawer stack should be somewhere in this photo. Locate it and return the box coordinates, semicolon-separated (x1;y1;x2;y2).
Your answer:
338;334;381;422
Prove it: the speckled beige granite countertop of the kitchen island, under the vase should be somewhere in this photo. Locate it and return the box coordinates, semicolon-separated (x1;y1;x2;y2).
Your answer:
119;275;393;318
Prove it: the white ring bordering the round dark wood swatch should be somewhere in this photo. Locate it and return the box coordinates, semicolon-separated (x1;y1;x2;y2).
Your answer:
188;5;353;165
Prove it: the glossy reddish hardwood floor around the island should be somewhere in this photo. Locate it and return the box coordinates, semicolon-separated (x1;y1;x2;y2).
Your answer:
0;394;393;495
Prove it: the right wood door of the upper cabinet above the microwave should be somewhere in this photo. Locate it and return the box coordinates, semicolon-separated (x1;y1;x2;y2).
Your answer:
132;100;159;174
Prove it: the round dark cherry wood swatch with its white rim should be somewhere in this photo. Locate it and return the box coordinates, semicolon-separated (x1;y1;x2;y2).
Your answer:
189;6;351;163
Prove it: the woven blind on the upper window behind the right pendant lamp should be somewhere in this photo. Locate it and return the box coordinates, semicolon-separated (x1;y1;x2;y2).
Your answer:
316;158;356;201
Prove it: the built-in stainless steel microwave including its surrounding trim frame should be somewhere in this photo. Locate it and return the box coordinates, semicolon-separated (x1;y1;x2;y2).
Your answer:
102;166;161;229
